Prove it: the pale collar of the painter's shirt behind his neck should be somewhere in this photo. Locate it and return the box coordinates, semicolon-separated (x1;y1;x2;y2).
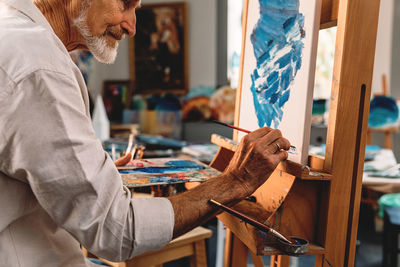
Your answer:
0;0;54;32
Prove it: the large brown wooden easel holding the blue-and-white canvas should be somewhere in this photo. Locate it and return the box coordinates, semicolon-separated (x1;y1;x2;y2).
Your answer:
211;0;380;267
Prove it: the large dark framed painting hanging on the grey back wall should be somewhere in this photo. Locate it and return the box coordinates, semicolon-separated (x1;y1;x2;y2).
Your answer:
129;2;188;94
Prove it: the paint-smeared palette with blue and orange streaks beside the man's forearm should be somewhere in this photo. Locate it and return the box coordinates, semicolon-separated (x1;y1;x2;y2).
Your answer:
118;158;220;187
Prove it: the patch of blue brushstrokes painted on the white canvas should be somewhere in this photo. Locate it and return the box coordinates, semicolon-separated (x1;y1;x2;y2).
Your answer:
250;0;305;128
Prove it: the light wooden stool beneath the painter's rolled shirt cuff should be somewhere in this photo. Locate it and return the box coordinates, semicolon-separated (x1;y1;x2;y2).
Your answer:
84;226;212;267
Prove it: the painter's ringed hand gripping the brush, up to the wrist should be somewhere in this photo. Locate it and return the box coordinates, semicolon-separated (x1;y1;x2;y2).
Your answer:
225;127;290;195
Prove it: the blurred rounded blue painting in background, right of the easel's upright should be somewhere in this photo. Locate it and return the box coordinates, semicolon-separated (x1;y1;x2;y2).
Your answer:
368;96;399;128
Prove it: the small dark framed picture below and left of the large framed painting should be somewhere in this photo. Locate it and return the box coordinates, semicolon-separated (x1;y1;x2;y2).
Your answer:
102;80;132;123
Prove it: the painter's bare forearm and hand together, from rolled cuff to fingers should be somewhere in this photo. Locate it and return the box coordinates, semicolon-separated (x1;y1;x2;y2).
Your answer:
169;127;290;237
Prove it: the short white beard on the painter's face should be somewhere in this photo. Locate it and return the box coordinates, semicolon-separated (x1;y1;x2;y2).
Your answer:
73;6;118;64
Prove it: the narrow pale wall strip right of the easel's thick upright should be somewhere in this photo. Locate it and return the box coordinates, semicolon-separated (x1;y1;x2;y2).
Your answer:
372;0;394;94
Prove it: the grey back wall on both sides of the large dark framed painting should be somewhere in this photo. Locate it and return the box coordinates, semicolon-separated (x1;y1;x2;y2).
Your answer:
88;0;218;96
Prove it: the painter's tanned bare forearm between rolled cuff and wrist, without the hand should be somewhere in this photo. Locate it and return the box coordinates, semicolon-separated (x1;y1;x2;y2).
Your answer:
169;174;248;238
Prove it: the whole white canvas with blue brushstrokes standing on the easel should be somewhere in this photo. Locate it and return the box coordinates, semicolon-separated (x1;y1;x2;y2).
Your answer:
235;0;321;164
